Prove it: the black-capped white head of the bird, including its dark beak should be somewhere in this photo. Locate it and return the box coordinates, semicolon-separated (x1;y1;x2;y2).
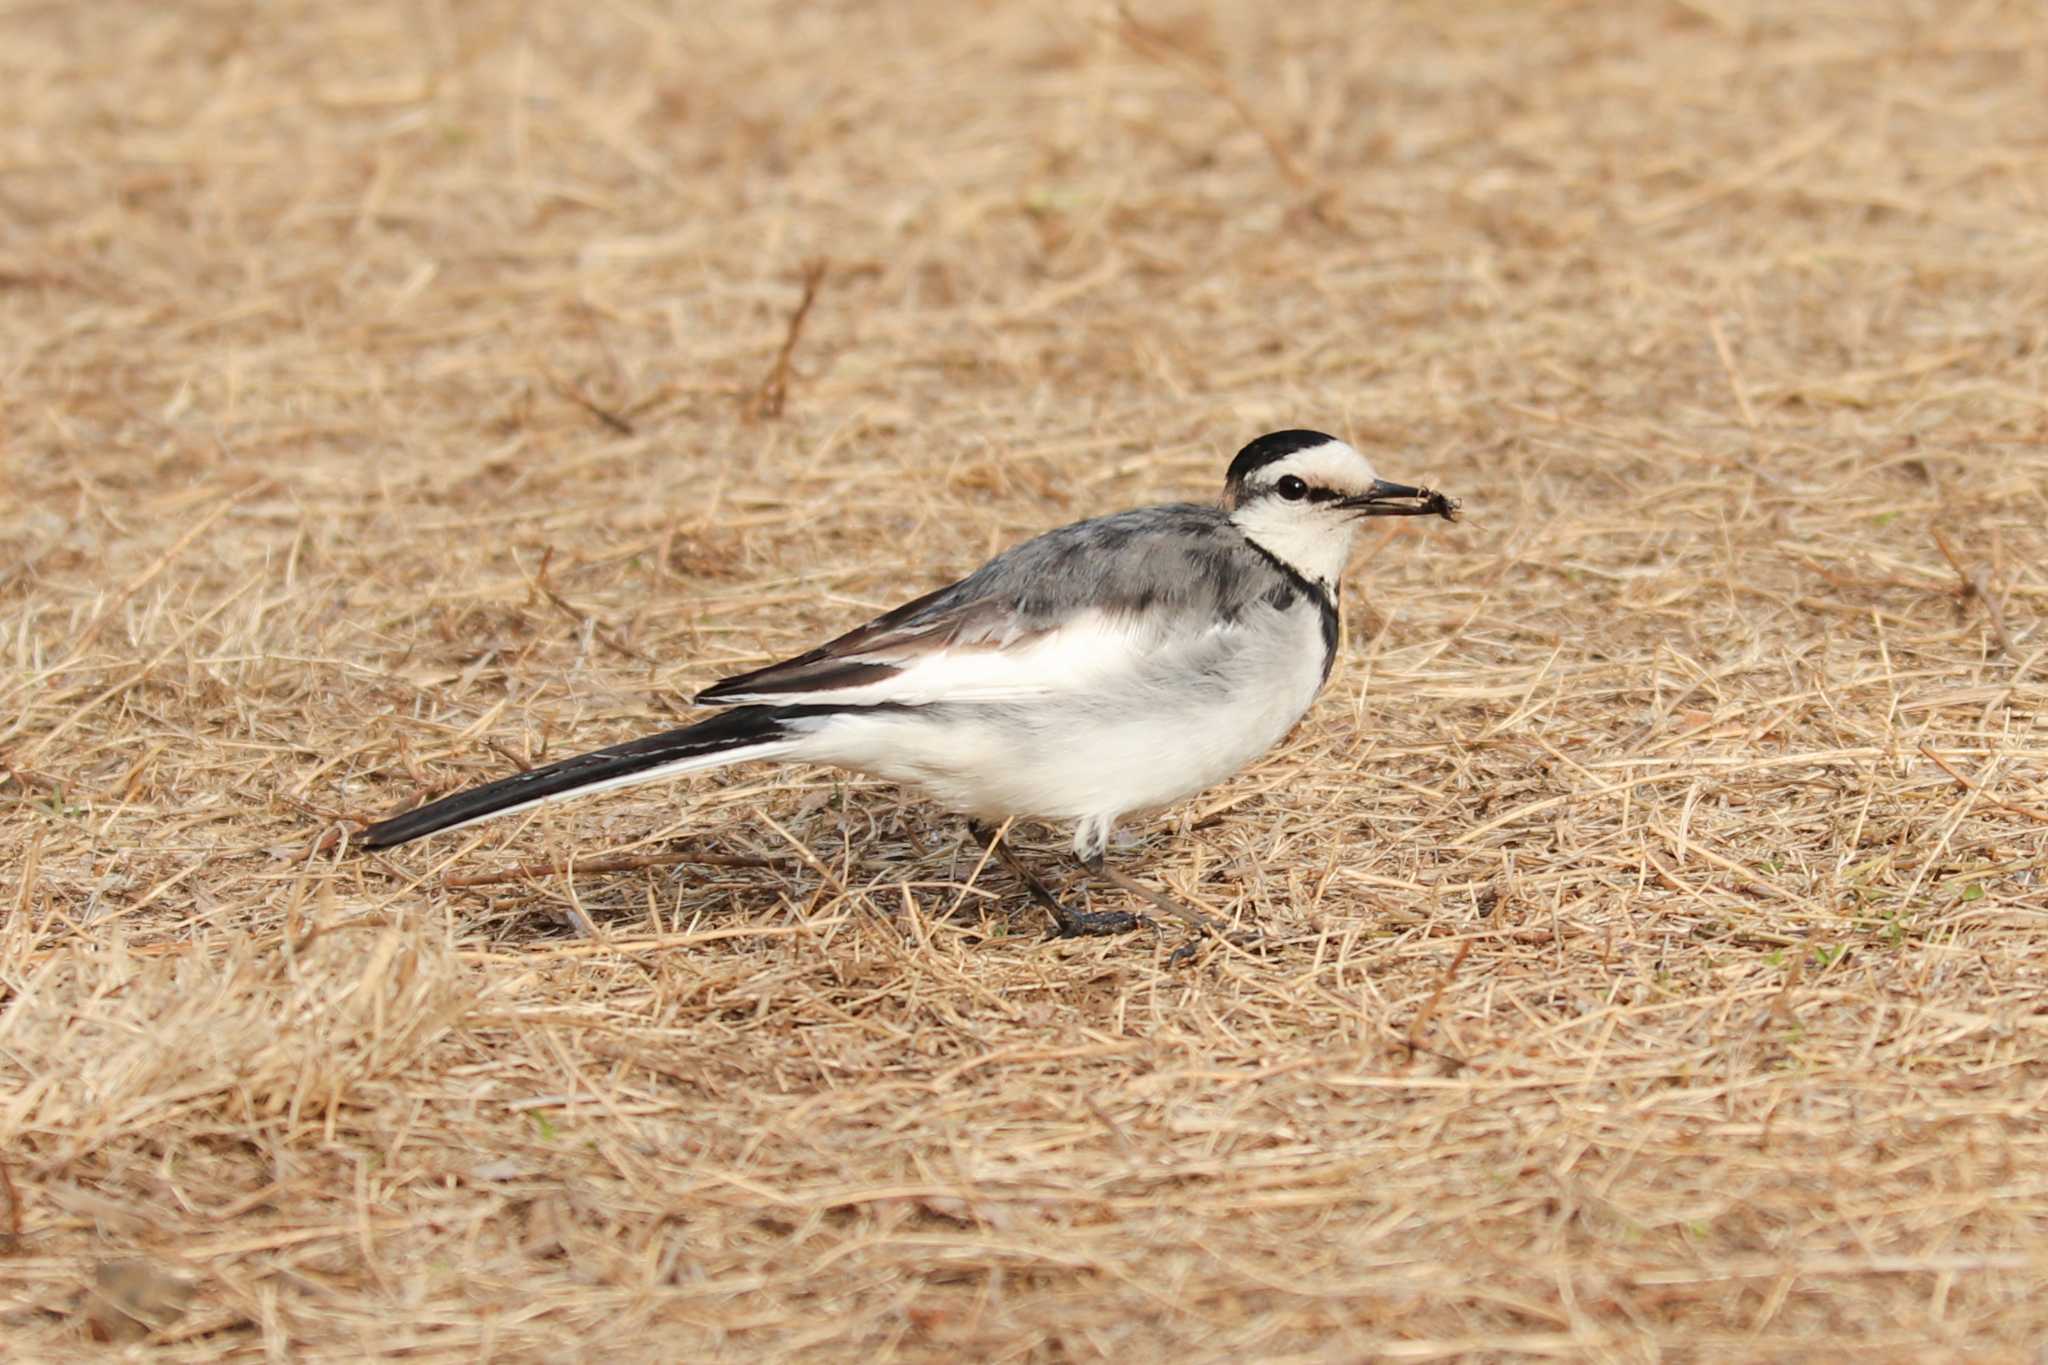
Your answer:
1223;432;1458;585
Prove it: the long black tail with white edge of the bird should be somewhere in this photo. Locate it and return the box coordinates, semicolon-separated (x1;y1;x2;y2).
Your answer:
356;706;838;849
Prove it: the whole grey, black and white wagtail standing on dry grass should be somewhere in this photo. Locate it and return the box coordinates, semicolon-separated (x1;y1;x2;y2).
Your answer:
356;430;1458;935
